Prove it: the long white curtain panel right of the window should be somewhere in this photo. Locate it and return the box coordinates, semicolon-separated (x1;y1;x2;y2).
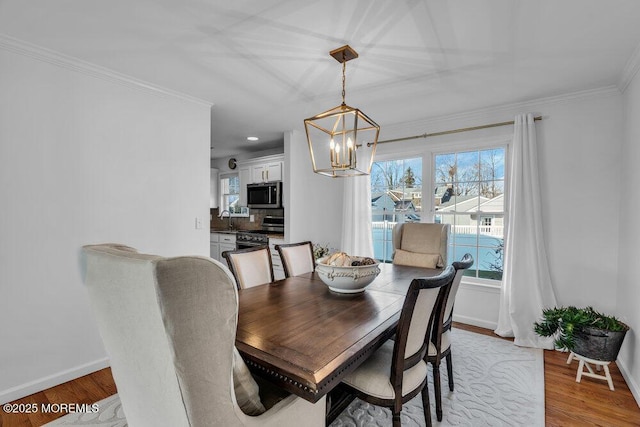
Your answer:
495;114;556;349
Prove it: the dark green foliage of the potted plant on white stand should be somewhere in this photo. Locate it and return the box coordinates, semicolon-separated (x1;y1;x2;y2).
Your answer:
533;306;625;351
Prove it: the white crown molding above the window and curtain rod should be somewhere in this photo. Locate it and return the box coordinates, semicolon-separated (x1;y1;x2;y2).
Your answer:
384;85;621;133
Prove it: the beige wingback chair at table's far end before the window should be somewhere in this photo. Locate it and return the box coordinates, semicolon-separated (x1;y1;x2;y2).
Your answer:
392;222;450;268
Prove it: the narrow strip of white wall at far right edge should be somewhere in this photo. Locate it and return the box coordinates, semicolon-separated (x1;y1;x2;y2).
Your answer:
617;69;640;405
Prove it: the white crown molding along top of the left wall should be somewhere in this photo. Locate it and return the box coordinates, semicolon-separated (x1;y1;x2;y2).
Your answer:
0;33;213;108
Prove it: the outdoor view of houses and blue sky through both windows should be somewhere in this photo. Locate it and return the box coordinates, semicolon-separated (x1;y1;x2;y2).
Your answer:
371;148;505;280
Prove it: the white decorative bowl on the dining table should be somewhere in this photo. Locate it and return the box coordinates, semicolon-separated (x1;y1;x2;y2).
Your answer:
316;256;380;294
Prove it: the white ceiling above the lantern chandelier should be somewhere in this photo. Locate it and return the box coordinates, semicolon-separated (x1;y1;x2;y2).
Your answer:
0;0;640;157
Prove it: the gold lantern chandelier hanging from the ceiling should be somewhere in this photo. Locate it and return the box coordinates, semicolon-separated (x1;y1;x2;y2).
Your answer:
304;45;380;178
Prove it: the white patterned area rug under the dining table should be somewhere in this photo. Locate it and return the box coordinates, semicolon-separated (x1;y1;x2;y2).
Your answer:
47;329;544;427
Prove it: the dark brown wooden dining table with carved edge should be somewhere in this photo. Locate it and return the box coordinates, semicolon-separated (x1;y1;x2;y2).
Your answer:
236;264;442;403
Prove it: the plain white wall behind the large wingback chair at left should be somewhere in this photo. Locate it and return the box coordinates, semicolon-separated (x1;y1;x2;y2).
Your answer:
0;43;211;402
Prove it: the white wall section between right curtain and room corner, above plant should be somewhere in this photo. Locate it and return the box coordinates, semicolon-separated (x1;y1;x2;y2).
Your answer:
538;91;623;312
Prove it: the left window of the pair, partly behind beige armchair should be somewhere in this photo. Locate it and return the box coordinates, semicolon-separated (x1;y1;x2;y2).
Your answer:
371;157;422;262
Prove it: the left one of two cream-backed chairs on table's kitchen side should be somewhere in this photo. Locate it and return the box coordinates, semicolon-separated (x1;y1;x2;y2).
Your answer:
222;246;273;289
